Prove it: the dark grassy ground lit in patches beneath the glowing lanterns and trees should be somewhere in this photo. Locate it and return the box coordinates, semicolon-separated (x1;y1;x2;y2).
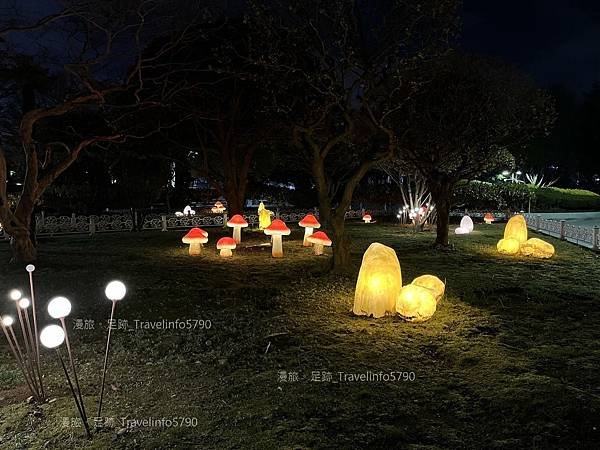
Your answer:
0;224;600;449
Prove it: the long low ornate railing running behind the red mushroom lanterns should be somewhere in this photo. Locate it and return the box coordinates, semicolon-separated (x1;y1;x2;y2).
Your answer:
24;209;392;238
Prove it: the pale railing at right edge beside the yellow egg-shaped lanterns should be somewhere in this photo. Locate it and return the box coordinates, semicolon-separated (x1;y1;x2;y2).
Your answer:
525;214;600;250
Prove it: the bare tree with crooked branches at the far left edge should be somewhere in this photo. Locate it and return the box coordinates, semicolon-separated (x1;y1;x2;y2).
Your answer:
0;0;203;261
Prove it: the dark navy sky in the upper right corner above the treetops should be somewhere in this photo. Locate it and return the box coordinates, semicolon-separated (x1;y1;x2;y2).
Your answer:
461;0;600;94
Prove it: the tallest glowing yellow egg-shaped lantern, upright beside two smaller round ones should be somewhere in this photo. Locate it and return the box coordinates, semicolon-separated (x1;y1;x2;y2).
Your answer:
352;242;402;318
